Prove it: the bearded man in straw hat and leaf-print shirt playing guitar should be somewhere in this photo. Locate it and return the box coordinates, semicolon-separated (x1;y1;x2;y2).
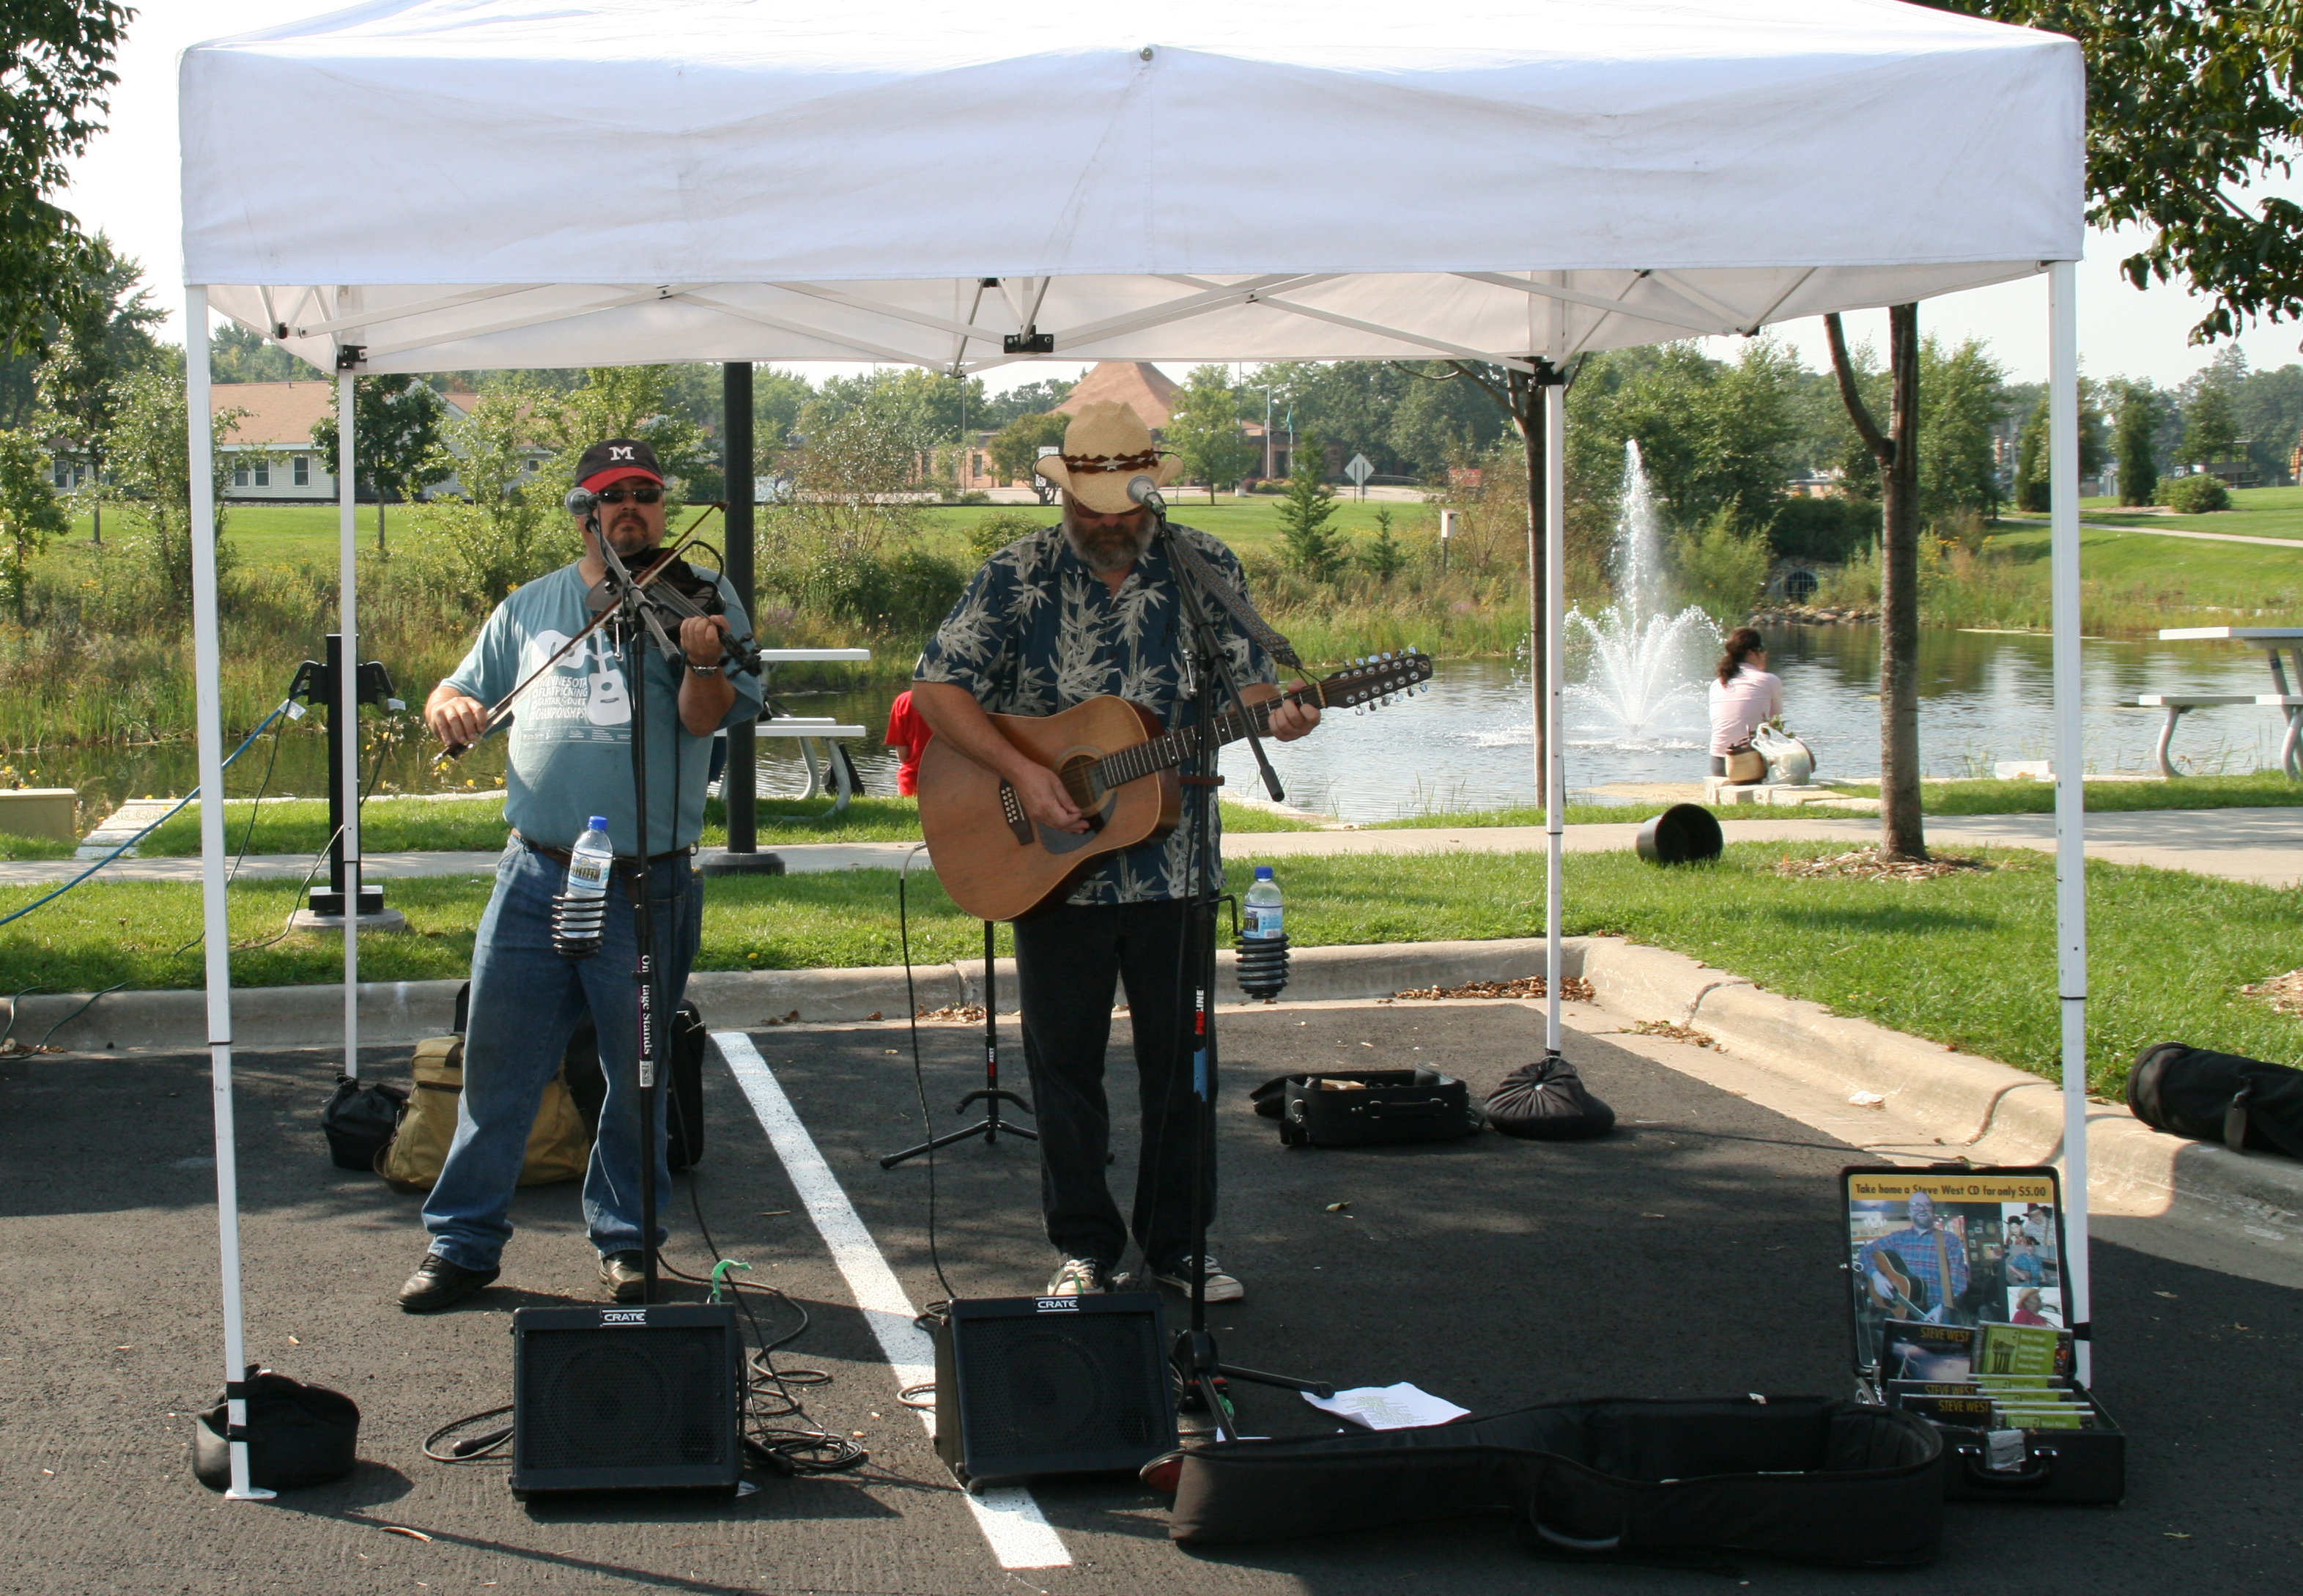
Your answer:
912;403;1320;1301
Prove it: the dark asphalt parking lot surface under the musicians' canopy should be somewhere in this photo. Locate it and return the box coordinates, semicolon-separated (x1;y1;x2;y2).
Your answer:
0;1002;2303;1596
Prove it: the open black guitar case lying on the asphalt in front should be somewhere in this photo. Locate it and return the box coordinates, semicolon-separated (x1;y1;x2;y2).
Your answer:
1169;1396;1944;1568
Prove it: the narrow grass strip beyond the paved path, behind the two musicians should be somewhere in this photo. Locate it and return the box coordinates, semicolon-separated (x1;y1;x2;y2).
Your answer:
130;797;1317;859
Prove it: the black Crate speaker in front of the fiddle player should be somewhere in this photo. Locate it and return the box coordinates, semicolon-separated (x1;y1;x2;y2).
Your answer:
518;1326;735;1469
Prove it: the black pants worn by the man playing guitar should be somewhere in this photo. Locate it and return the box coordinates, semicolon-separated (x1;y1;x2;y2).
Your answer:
1016;901;1216;1269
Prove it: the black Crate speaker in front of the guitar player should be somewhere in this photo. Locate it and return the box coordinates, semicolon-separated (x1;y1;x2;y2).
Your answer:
953;1315;1165;1455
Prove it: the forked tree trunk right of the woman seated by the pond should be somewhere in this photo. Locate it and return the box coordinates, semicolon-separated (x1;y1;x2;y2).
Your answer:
1824;304;1928;859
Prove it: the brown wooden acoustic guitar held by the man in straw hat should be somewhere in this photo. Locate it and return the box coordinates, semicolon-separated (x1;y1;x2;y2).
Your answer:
919;649;1433;919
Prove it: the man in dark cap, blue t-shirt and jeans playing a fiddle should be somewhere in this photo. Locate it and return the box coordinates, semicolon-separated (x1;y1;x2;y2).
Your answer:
401;437;760;1312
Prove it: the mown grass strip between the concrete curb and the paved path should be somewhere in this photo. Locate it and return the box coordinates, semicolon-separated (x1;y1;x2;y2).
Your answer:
0;843;2303;1094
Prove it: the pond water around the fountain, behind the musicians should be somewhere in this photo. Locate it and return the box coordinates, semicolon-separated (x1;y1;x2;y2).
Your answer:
18;627;2282;820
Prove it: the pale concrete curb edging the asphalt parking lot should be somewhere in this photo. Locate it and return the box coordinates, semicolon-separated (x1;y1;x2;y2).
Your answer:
0;937;2303;1241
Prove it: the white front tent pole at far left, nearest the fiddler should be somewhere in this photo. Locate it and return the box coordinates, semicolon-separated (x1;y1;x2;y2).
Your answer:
184;288;272;1501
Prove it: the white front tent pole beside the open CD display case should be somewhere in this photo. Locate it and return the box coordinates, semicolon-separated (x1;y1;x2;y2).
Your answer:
2047;260;2093;1384
